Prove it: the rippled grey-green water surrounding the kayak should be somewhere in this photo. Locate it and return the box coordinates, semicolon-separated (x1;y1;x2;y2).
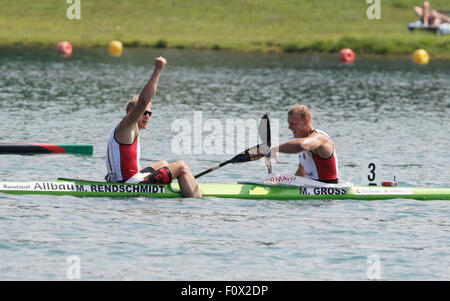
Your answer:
0;48;450;280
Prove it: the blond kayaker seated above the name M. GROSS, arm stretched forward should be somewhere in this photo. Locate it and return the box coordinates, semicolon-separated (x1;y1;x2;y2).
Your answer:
271;105;338;183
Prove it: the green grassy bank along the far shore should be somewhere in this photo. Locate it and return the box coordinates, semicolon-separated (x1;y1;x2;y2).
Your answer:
0;0;450;57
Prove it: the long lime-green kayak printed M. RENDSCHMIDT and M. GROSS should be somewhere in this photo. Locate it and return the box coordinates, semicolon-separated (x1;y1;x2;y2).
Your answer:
0;178;450;200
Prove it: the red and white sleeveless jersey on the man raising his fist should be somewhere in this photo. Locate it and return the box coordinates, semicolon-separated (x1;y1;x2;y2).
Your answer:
105;129;141;182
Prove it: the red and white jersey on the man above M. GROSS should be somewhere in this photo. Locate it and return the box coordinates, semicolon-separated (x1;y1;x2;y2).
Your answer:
299;130;338;180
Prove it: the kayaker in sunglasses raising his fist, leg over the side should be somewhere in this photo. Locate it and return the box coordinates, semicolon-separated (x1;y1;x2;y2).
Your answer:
105;57;201;197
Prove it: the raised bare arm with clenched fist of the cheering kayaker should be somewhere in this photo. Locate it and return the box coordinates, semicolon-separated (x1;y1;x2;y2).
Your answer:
116;57;167;144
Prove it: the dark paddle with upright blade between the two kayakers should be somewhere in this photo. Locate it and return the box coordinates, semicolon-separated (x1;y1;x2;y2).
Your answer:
194;114;270;179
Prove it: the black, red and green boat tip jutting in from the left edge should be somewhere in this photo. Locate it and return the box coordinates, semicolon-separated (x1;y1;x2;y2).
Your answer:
0;141;94;155
